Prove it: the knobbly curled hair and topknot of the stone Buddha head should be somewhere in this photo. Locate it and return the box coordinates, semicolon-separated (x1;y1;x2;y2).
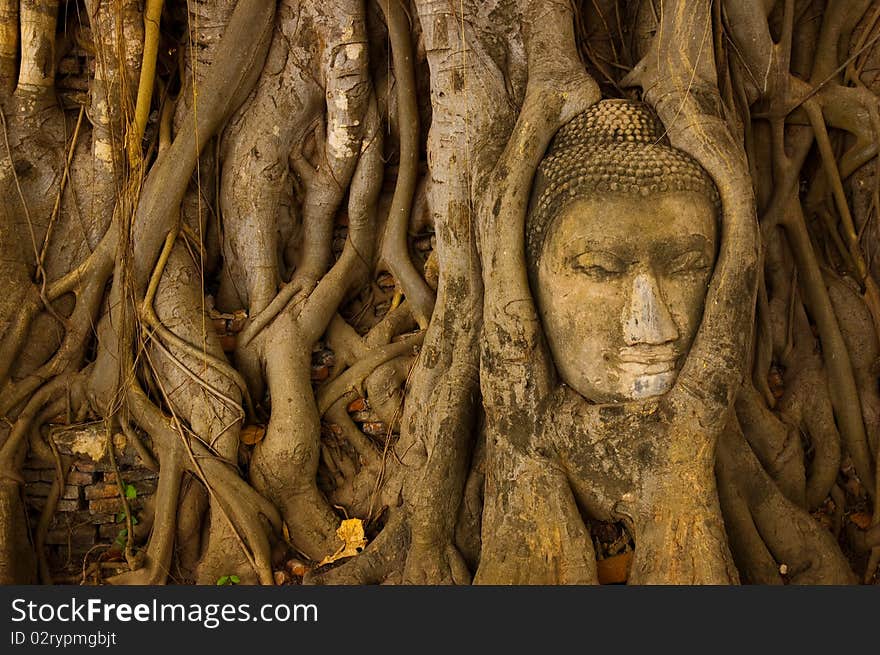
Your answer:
526;100;720;263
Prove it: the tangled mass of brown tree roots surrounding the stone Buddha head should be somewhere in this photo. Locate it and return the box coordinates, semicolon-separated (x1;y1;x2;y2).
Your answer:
0;0;880;584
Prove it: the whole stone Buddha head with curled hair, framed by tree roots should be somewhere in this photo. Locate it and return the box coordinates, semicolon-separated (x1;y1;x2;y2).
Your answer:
526;100;720;403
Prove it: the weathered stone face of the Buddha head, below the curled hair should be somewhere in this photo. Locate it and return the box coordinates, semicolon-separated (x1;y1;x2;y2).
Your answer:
535;192;717;402
